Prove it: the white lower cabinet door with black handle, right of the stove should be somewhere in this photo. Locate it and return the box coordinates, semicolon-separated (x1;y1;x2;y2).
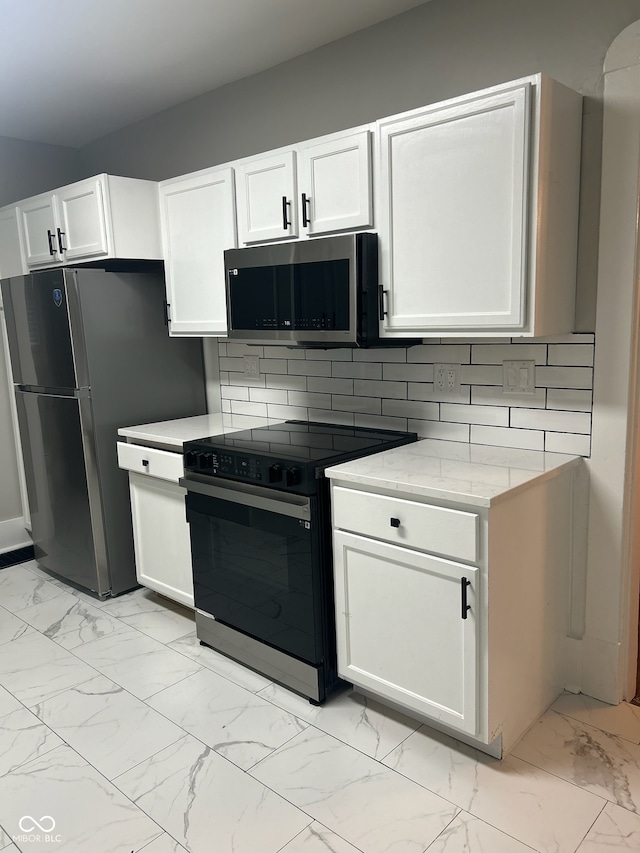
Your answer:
333;531;478;735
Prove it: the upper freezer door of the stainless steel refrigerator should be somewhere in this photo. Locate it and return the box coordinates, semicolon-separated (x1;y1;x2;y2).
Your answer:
2;269;81;388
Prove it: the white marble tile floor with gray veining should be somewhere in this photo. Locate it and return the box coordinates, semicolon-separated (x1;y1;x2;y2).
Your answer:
0;562;640;853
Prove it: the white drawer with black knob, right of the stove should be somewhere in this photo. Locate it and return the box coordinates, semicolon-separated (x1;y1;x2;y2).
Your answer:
331;486;478;563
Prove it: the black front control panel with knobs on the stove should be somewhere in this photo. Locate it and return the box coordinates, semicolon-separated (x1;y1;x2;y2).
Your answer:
184;442;315;494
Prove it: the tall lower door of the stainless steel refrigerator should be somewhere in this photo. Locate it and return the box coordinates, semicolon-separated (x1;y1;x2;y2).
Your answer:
16;390;110;594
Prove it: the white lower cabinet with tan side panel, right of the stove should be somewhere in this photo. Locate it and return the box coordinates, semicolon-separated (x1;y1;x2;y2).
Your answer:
327;462;586;755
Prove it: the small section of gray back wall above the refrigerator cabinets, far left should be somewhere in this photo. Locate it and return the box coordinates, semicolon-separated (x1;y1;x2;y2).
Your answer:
0;136;84;207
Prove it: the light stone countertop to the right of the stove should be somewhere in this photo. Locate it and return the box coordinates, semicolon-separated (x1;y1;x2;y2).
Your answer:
325;439;581;507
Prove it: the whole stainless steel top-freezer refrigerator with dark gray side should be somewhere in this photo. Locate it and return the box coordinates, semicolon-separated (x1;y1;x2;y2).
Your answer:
1;269;206;596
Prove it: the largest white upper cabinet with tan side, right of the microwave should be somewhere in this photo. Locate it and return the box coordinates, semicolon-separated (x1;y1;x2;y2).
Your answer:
377;75;581;337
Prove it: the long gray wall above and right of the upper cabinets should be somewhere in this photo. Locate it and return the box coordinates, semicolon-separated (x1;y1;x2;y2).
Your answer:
81;0;640;331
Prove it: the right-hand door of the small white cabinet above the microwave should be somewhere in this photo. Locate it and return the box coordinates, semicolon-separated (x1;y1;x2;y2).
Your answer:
298;130;373;234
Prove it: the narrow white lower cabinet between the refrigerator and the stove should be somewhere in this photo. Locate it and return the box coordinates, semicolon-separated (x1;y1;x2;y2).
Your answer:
118;442;193;607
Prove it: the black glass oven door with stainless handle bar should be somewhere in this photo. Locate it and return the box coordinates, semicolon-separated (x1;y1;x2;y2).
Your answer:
180;475;325;665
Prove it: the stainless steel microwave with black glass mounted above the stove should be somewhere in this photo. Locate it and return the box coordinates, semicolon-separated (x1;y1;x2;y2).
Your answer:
224;232;396;347
